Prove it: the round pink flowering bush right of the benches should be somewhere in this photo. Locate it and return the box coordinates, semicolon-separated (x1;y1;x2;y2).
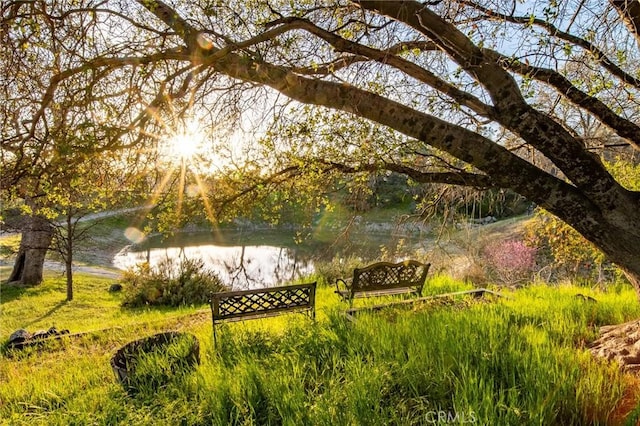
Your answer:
483;240;537;286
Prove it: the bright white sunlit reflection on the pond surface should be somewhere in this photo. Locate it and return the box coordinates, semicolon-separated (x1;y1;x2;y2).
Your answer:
113;244;313;290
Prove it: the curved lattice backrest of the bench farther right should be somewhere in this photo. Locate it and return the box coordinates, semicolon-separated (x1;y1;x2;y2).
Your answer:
351;260;431;293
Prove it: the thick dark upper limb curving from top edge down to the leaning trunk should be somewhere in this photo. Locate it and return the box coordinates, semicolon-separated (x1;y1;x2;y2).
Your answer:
357;0;628;206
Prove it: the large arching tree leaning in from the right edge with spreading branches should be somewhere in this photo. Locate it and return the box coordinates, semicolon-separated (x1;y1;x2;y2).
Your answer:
3;0;640;296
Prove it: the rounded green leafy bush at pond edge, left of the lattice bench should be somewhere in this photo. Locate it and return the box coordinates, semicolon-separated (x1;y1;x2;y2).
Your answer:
122;259;226;307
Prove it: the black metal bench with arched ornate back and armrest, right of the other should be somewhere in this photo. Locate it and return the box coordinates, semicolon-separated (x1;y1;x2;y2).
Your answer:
336;260;431;304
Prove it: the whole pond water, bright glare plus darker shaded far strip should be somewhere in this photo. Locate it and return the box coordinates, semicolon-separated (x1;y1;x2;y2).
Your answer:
113;231;428;290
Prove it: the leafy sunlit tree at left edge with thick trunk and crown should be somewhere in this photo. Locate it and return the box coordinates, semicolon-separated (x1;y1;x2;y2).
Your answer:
0;1;175;285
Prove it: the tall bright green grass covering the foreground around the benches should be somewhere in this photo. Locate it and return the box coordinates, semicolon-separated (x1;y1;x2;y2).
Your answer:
0;277;640;425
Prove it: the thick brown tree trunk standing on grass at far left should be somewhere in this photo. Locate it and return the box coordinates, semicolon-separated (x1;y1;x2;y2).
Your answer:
9;216;53;286
